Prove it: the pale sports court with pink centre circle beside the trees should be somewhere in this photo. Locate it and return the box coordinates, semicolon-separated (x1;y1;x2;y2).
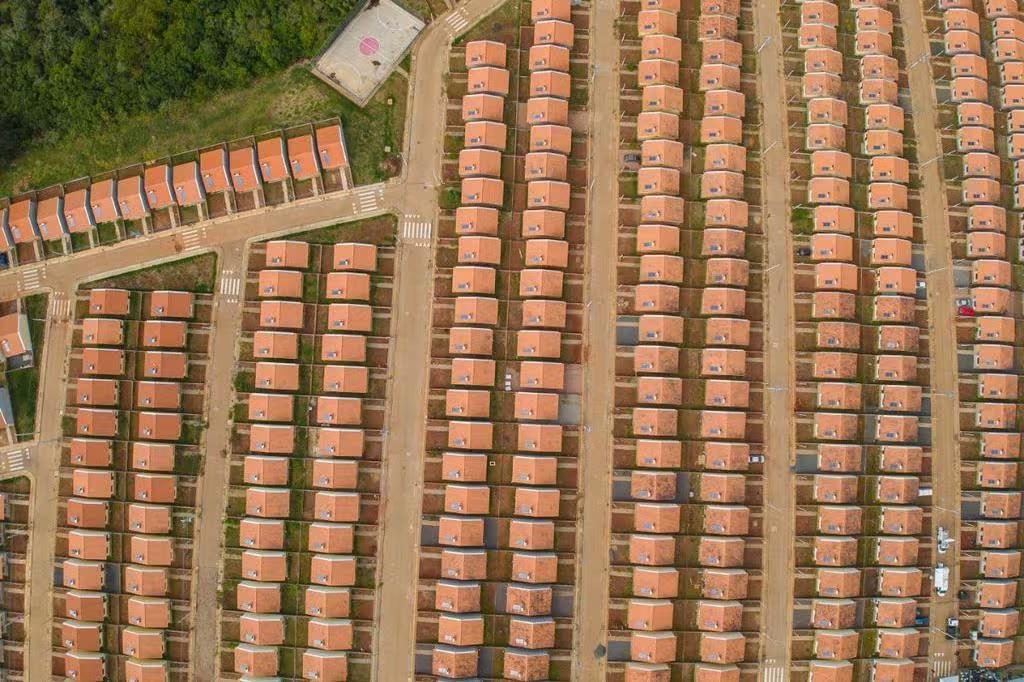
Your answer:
314;0;425;104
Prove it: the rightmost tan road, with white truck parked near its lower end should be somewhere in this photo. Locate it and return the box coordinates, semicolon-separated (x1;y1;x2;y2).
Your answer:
899;0;961;671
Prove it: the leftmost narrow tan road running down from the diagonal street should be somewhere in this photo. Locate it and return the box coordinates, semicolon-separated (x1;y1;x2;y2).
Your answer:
25;287;74;680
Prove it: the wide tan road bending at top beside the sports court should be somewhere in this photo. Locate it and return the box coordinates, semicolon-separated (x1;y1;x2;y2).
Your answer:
373;0;502;682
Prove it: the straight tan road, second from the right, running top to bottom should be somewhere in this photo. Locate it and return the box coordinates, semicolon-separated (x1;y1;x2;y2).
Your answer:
754;0;796;679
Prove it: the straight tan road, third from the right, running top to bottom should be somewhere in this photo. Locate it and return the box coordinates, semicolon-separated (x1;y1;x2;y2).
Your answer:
572;0;618;681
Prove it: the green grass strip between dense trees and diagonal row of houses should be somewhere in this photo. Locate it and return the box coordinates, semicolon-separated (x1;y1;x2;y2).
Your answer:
0;67;409;196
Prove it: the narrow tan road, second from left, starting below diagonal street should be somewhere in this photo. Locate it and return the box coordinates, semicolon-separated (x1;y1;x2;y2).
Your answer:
188;242;247;680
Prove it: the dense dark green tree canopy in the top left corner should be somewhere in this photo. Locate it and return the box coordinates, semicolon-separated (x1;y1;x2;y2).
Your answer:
0;0;355;159
